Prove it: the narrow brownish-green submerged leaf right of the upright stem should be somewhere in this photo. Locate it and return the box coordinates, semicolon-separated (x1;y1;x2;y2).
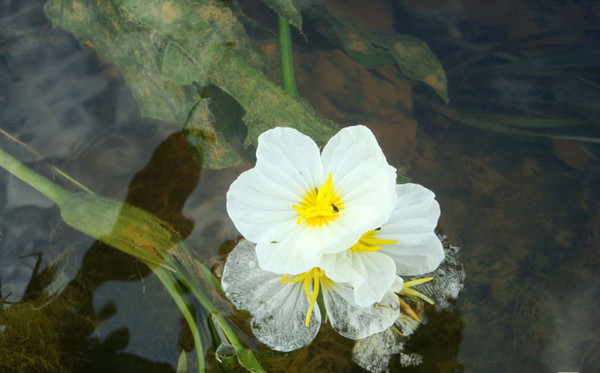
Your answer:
310;5;448;102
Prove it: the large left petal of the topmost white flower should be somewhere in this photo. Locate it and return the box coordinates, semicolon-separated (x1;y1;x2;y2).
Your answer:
227;128;324;242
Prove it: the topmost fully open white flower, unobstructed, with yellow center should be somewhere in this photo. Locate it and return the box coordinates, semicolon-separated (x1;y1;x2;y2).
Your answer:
227;126;396;274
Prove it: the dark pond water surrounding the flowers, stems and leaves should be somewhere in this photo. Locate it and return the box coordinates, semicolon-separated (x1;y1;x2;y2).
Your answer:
0;0;600;373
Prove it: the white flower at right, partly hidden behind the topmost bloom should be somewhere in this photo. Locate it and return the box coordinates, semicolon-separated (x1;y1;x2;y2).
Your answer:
320;184;444;307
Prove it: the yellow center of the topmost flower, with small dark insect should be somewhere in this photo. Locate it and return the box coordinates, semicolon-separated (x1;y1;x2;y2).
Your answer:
293;174;344;227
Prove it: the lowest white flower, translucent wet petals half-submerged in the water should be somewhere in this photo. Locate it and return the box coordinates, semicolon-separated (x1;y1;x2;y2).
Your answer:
221;240;400;351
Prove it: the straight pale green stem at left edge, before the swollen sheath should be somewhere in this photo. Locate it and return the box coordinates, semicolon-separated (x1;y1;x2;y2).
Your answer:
0;149;71;206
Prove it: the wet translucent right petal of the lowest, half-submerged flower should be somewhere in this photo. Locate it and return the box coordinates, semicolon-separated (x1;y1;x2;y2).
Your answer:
323;283;400;339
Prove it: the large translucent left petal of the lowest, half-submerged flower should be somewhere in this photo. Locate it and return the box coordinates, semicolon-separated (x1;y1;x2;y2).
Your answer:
221;240;321;352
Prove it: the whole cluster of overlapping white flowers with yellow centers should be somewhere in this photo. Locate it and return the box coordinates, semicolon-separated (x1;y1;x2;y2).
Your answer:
222;126;444;364
